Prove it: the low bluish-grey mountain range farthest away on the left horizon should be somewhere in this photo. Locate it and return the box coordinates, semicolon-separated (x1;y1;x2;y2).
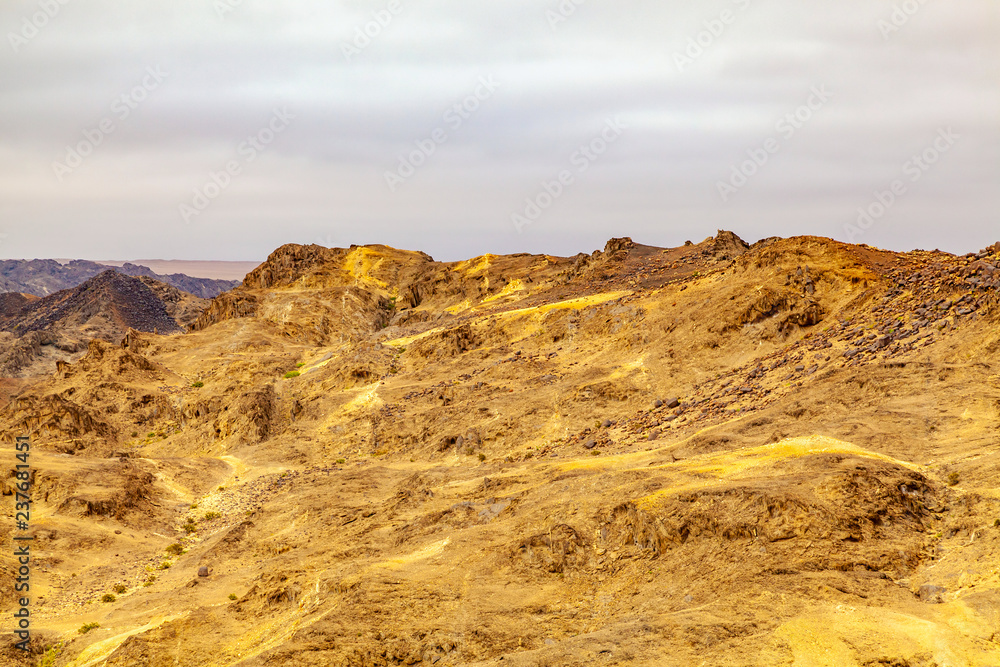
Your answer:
0;259;240;299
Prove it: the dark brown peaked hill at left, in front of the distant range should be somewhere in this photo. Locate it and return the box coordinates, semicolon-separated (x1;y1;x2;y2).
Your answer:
0;270;209;377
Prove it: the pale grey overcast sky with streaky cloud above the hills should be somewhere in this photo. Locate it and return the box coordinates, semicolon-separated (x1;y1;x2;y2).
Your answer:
0;0;1000;261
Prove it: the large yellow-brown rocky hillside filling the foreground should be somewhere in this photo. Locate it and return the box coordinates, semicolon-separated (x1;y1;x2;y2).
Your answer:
0;232;1000;667
